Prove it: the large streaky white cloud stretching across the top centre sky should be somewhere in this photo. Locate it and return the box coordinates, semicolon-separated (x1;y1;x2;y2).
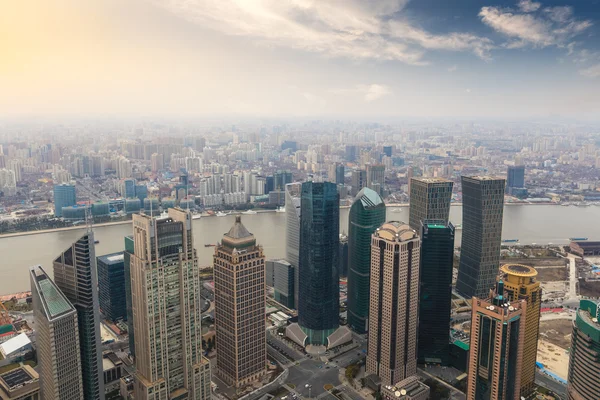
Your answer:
148;0;493;65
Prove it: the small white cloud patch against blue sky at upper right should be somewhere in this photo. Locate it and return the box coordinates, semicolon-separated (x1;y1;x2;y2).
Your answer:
479;1;592;49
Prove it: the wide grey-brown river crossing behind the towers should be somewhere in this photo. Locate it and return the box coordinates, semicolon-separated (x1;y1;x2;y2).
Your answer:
0;205;600;294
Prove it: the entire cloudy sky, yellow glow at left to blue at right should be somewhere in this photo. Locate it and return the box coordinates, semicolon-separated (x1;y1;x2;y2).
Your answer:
0;0;600;121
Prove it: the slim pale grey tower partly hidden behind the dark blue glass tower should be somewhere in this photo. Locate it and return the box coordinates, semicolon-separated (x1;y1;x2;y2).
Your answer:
285;183;302;307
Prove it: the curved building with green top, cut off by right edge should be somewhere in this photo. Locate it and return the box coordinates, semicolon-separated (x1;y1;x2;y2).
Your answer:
567;300;600;400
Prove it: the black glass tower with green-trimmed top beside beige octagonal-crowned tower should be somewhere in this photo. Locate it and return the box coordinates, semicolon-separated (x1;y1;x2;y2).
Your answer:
418;220;454;365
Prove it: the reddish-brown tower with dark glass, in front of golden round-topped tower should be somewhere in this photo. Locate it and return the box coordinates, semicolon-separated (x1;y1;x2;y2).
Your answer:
467;280;527;400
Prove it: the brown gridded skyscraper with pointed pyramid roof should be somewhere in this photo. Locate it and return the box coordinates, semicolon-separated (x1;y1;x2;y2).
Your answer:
214;215;267;388
